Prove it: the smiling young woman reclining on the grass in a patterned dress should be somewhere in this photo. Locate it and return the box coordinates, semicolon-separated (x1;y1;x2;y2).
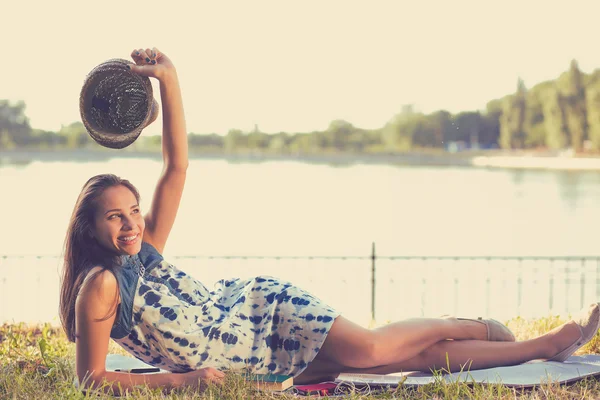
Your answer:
60;48;600;391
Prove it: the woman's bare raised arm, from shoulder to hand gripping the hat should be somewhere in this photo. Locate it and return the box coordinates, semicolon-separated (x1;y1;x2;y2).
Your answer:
131;47;188;253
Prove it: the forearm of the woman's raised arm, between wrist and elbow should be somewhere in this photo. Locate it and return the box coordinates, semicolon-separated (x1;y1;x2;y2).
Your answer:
159;68;188;170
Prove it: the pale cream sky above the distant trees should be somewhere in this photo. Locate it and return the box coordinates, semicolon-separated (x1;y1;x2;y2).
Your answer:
0;0;600;135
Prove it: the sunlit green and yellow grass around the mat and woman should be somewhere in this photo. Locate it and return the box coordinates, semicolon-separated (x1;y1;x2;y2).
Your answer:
0;317;600;400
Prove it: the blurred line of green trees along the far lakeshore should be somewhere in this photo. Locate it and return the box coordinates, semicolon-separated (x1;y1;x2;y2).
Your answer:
0;60;600;154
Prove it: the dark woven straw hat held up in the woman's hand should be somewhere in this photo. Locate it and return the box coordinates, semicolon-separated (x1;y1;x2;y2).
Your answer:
79;59;158;149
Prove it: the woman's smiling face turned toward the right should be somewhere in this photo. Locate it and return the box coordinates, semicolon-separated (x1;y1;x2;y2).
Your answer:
93;185;146;255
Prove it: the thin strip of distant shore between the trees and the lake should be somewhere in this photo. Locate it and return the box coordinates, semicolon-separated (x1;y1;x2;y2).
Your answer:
0;149;600;171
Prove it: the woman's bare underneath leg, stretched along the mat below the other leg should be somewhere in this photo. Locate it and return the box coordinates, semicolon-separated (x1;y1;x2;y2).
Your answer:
295;322;579;383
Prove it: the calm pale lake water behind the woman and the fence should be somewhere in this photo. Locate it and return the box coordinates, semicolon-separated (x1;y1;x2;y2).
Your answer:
0;159;600;322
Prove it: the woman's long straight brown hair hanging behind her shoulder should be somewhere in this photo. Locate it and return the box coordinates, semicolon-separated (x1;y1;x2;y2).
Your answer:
60;174;140;342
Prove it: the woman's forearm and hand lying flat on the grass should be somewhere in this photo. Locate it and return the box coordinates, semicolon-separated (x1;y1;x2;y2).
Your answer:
83;371;183;396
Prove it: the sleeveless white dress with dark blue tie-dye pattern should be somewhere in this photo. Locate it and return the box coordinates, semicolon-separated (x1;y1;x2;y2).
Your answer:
111;242;339;376
